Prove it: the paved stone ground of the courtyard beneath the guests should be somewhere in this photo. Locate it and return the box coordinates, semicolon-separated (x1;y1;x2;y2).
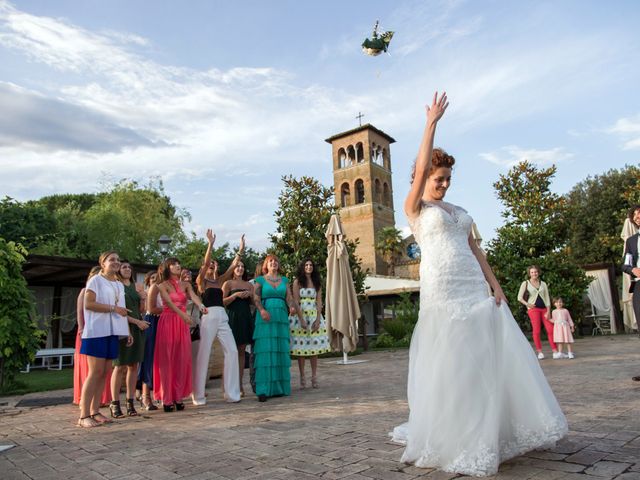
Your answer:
0;336;640;480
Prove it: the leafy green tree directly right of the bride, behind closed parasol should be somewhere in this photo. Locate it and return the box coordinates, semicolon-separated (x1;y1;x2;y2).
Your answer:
487;161;589;328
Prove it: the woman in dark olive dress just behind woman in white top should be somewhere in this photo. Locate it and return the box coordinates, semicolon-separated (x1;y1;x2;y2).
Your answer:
109;260;149;418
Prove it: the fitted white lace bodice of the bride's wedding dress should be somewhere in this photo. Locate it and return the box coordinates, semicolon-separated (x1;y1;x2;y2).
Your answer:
409;202;488;308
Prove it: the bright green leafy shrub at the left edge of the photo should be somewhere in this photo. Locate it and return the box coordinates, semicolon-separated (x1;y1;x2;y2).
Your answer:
0;237;42;392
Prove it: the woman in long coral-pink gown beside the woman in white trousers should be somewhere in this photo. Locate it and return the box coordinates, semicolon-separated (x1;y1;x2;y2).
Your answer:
153;258;207;412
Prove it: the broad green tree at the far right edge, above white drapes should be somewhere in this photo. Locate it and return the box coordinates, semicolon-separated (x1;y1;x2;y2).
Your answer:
566;166;640;265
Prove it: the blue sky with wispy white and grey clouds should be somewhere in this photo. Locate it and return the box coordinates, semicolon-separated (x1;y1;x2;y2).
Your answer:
0;0;640;253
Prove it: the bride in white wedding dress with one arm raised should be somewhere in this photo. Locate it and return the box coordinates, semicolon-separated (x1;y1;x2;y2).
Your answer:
392;92;567;476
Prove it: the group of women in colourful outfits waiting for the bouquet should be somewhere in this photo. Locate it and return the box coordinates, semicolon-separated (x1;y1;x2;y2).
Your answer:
74;230;330;428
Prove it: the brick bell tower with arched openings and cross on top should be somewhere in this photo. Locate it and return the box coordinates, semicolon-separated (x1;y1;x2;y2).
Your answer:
325;123;396;275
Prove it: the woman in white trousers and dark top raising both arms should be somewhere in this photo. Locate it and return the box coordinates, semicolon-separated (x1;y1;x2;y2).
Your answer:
192;229;244;405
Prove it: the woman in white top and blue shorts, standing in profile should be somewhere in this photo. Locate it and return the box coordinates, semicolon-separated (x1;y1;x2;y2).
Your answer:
78;251;133;428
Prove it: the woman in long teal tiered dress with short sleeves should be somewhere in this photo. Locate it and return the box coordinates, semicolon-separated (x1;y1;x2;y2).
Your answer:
253;255;299;402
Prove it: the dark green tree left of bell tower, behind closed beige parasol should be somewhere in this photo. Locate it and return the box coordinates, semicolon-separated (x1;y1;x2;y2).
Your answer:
269;175;366;294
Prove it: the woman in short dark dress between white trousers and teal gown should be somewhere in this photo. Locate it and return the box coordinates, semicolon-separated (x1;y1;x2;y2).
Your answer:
222;261;253;397
